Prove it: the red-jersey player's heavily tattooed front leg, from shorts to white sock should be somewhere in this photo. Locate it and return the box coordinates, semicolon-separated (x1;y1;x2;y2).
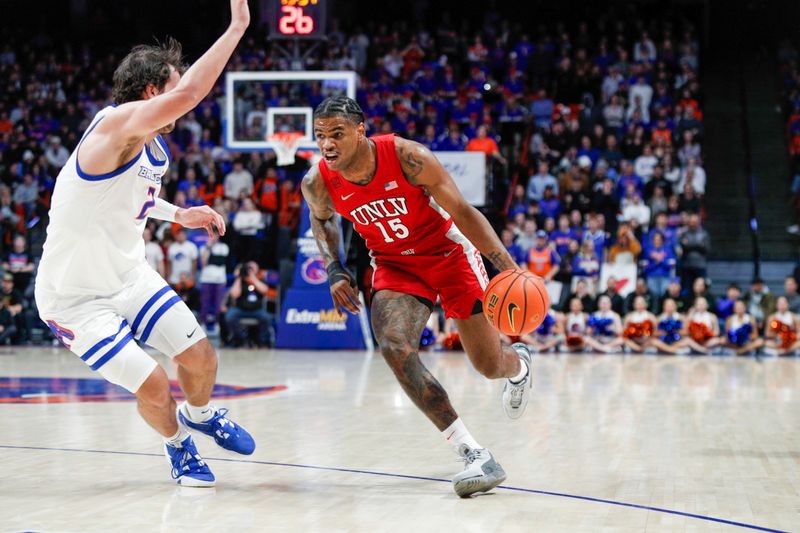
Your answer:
372;290;458;431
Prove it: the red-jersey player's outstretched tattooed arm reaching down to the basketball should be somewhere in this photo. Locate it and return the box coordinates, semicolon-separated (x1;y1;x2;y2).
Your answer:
395;138;519;272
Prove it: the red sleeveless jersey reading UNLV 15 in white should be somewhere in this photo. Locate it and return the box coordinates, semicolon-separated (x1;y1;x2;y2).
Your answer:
319;135;456;258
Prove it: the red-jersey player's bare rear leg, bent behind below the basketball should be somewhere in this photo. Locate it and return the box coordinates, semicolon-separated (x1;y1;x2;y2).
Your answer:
456;313;522;379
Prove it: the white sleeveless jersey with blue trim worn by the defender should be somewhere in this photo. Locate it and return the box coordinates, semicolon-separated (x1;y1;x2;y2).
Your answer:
36;107;169;296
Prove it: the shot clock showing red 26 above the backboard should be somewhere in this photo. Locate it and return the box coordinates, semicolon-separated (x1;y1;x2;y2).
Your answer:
269;0;329;39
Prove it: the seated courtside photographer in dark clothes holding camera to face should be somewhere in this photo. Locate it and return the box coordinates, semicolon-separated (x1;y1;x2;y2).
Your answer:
225;261;272;347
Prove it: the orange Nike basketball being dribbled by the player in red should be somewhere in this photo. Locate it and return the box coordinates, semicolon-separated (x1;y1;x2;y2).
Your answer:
483;270;550;336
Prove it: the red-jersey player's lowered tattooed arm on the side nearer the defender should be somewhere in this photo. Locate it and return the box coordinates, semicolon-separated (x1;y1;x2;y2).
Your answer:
301;165;340;267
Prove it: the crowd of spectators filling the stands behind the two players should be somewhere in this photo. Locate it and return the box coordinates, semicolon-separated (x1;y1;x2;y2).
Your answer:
0;8;792;352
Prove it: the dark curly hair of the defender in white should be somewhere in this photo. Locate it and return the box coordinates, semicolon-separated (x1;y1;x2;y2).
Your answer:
111;37;186;104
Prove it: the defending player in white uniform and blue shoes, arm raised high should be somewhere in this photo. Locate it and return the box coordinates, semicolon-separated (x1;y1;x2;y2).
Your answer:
36;0;255;486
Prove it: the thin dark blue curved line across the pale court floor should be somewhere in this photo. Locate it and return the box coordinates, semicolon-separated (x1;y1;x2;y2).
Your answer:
0;444;790;533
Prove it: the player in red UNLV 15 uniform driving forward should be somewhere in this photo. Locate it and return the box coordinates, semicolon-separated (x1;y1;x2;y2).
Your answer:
302;96;531;497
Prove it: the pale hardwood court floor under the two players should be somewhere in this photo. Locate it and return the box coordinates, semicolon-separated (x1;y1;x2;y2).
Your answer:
0;348;800;533
